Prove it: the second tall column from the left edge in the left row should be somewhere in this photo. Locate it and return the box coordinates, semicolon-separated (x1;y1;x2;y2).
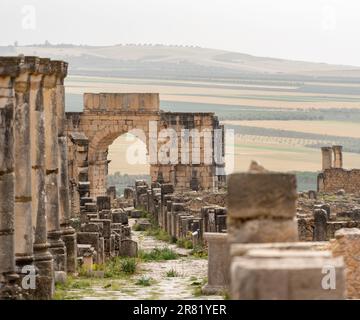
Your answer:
14;59;35;277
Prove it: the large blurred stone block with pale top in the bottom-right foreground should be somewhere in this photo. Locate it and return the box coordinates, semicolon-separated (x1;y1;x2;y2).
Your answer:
230;250;345;300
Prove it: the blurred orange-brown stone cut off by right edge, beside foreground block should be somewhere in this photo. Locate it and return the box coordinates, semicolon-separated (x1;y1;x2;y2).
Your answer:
331;228;360;299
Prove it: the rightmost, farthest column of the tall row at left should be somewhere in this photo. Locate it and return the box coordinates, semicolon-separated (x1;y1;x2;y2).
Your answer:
53;61;77;273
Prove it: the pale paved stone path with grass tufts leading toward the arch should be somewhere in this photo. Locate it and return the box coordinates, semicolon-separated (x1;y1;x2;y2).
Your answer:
57;221;223;300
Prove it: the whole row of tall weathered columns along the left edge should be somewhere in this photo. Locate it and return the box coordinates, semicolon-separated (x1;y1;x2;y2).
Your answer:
0;57;76;299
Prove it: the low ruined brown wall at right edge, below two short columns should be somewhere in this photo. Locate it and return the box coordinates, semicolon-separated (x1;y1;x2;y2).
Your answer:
318;168;360;193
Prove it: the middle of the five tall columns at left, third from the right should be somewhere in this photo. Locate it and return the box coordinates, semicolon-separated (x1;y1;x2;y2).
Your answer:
30;58;54;300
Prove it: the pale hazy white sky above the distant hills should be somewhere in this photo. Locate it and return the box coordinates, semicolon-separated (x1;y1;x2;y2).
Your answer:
0;0;360;66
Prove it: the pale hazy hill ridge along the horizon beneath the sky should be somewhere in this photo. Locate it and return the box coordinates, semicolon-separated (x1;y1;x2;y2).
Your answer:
0;42;360;81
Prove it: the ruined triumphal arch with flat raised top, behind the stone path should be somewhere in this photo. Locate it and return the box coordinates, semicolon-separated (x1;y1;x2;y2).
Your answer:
66;93;224;211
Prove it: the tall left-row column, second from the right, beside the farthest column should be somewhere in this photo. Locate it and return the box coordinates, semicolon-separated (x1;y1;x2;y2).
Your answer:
43;62;66;271
